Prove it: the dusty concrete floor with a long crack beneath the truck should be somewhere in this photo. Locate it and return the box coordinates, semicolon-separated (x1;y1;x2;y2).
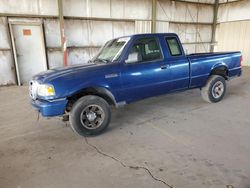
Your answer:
0;68;250;188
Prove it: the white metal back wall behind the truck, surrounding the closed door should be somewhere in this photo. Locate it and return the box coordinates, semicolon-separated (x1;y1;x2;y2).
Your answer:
0;0;214;85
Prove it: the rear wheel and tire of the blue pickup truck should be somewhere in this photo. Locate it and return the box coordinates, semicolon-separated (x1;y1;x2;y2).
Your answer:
201;75;226;103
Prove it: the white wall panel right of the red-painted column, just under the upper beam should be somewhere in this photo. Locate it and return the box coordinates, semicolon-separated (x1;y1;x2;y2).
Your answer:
65;20;135;47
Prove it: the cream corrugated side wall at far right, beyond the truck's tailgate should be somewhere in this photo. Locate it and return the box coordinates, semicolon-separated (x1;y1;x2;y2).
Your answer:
215;0;250;66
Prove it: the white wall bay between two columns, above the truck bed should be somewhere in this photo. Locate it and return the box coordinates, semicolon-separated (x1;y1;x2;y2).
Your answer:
157;0;213;53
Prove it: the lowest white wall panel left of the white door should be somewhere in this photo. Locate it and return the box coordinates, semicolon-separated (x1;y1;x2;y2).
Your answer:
0;51;16;85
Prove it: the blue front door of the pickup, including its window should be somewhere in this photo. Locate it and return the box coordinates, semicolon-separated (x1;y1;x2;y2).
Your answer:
121;36;170;102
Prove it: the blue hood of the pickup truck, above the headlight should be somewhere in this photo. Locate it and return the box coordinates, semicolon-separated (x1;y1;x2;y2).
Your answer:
33;63;101;83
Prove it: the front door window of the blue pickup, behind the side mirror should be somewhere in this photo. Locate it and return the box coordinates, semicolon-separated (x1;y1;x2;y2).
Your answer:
126;37;163;63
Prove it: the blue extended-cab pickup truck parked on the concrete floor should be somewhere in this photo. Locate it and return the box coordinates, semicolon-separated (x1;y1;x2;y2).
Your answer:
29;33;242;136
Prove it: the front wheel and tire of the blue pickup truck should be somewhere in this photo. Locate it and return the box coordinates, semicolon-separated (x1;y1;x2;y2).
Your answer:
69;95;111;136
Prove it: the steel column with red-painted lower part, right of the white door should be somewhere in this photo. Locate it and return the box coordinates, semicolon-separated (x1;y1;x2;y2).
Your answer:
58;0;68;66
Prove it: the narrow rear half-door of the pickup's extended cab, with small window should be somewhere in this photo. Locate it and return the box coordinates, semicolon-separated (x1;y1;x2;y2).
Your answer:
165;36;190;91
